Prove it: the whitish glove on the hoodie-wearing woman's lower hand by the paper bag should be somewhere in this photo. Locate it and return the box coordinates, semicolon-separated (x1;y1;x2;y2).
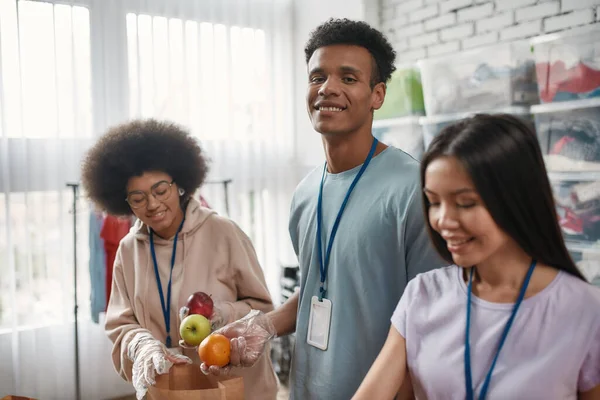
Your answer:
127;332;192;400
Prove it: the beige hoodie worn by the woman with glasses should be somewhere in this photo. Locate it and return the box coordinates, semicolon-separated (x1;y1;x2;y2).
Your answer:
105;199;277;400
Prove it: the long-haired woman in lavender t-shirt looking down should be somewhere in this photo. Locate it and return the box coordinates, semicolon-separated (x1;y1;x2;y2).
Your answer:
354;115;600;400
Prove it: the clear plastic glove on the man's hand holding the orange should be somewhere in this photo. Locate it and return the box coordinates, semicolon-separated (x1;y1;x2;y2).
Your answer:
200;310;277;375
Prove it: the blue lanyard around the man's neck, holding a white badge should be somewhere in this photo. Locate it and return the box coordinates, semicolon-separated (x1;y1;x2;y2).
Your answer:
317;138;378;301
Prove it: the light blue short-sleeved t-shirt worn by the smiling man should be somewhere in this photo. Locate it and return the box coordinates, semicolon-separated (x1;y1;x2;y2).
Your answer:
289;147;445;400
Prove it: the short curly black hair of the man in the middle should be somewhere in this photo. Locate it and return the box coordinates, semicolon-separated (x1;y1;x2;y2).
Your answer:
304;18;396;87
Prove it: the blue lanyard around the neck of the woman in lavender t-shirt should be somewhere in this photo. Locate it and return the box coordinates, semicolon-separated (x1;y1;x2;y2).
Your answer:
465;260;537;400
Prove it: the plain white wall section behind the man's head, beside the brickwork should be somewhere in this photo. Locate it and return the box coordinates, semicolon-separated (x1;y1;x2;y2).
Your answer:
293;0;378;173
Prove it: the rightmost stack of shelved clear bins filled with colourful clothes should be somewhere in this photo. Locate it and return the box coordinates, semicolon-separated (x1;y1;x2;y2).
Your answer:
531;29;600;286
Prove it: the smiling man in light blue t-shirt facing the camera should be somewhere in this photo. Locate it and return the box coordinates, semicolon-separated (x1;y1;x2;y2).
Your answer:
204;19;443;400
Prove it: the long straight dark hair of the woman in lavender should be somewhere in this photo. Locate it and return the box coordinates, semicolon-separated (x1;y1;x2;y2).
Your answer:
421;114;586;281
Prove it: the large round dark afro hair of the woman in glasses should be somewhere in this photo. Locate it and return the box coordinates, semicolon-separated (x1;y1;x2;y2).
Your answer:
81;119;208;215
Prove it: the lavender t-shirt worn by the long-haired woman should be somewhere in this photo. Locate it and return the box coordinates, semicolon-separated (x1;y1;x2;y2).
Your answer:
392;266;600;400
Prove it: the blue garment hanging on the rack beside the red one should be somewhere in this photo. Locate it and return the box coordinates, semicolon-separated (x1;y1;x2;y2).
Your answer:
89;211;106;323
